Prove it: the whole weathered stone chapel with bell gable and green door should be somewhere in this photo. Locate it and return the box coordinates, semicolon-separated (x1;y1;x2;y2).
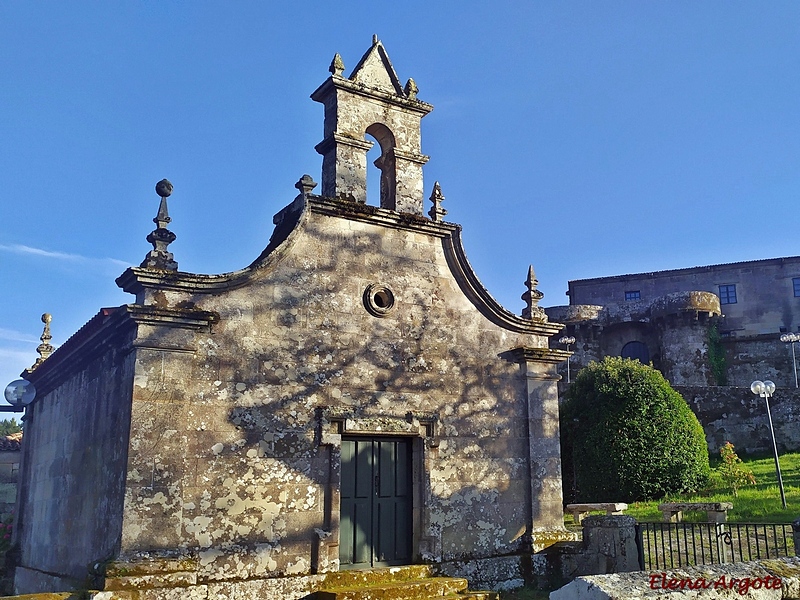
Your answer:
15;38;568;599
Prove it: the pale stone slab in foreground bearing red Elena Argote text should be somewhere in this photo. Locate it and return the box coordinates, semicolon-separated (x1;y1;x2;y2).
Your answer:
550;557;800;600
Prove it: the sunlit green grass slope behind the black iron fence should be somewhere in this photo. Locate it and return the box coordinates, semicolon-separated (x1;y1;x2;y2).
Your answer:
604;453;800;523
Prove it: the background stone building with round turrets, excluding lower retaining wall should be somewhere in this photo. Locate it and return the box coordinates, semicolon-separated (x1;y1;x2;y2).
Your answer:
546;256;800;387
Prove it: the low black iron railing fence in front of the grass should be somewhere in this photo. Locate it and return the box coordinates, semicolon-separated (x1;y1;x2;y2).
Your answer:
636;523;795;571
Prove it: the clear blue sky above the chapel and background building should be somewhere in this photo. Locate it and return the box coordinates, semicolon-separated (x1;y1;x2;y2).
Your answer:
0;0;800;394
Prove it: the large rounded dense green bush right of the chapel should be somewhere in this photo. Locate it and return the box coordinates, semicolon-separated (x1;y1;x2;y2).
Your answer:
561;357;710;502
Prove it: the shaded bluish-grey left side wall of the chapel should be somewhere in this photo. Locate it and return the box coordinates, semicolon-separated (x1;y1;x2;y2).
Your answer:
15;313;133;591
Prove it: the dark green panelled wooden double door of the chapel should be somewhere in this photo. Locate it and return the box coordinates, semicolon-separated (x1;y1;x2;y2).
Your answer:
339;437;411;569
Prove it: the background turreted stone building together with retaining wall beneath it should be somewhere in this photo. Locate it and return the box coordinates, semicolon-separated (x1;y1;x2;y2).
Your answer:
545;257;800;453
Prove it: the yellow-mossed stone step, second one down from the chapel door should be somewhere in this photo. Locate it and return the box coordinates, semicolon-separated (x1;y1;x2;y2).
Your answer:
316;577;468;600
